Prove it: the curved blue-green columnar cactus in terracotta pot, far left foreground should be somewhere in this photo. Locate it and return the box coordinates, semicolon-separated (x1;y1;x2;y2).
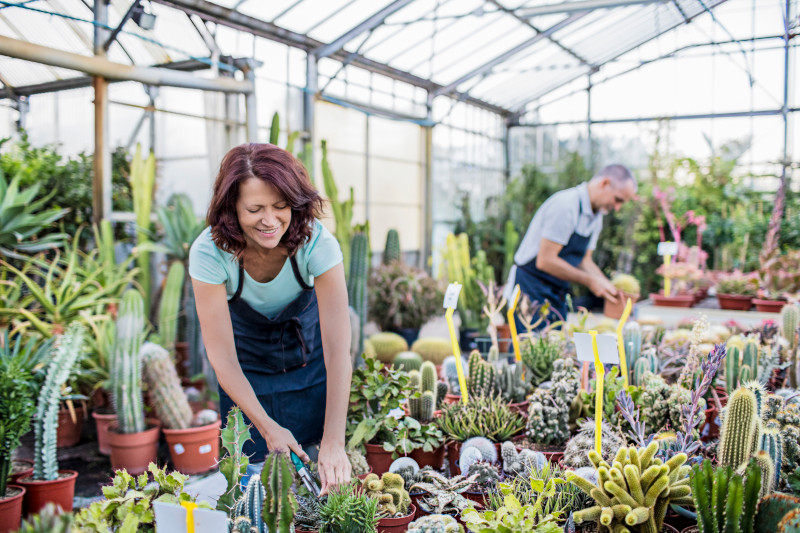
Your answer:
17;322;84;513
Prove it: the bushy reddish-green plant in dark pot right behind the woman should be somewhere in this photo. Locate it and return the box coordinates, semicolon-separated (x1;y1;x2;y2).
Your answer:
369;261;443;345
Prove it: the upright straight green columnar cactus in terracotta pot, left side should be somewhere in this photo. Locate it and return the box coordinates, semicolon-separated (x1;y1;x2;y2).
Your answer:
108;289;159;475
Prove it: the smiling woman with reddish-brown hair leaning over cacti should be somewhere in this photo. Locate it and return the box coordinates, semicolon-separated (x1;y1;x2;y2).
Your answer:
189;143;351;494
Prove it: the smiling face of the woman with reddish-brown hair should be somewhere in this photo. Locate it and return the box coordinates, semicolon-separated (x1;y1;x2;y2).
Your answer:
236;177;292;249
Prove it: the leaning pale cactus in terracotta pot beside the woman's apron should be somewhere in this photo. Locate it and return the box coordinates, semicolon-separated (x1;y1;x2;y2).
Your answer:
141;340;221;474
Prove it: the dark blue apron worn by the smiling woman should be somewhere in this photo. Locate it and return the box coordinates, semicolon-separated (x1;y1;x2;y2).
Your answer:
219;256;326;463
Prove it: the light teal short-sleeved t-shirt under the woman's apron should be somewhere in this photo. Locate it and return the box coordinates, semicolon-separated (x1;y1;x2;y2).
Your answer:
189;220;343;318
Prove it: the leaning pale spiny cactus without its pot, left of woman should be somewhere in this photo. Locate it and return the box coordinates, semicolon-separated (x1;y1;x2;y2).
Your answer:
140;342;192;429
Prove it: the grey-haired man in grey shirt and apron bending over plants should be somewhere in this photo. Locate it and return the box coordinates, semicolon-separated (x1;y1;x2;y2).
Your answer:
505;165;636;321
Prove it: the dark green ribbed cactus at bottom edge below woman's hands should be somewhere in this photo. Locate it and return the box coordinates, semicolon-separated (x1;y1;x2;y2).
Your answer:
261;453;297;533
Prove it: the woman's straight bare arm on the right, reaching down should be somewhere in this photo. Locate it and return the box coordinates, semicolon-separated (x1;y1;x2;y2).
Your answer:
314;263;353;493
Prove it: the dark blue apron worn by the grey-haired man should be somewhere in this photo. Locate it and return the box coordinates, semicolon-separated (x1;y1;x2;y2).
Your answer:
515;198;592;329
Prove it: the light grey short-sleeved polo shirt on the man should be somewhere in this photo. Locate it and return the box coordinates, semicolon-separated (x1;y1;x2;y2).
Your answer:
504;182;603;298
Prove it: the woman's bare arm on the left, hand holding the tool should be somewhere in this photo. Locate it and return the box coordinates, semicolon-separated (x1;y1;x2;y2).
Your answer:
192;279;310;462
